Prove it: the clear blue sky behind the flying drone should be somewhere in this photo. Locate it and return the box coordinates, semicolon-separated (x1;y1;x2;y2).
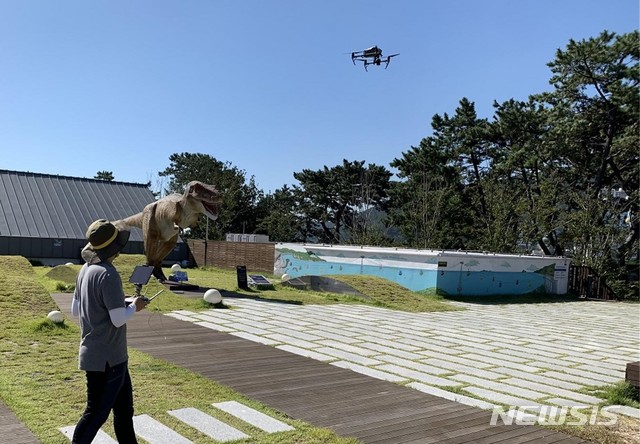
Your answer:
0;0;640;192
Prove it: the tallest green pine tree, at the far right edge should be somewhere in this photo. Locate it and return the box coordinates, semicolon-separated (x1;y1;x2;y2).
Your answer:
539;31;640;275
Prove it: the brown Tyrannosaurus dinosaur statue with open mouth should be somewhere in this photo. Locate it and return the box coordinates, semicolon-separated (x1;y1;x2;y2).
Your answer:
114;180;222;281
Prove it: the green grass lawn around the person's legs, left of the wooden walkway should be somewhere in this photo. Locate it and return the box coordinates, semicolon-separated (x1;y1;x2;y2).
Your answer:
0;256;357;444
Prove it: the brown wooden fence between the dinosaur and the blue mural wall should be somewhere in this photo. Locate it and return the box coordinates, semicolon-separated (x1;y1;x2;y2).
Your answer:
187;239;276;273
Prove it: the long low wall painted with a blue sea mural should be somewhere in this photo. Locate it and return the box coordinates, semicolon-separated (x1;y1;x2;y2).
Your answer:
274;244;569;295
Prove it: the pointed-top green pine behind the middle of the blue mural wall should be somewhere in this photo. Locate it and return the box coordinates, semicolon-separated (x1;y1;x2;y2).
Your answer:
391;98;496;249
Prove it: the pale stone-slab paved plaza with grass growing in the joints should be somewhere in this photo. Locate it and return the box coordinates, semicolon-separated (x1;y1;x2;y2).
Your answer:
171;298;640;416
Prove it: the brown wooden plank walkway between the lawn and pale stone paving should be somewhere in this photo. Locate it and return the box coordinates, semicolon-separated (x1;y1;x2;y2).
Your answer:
54;294;585;444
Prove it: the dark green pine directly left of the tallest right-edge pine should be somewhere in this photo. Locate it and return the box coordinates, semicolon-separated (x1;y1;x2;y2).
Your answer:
488;98;563;255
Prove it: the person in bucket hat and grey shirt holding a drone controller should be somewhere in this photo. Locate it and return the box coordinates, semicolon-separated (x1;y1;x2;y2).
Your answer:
71;219;148;444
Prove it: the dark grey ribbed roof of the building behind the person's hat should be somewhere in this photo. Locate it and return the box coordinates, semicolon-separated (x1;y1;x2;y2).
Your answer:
0;170;155;241
